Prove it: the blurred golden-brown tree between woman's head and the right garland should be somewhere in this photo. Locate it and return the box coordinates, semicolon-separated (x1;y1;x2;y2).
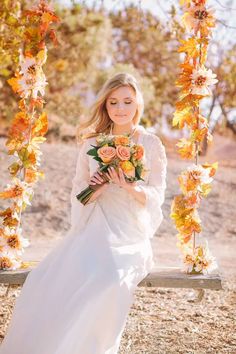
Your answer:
111;6;179;123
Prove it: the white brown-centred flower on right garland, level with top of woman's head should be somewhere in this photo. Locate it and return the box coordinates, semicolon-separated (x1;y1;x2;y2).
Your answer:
190;66;218;96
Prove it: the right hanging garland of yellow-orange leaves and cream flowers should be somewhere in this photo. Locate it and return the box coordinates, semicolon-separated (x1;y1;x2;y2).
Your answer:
170;0;218;274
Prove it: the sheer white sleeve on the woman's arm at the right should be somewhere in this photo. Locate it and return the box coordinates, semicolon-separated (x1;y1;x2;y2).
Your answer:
136;135;167;238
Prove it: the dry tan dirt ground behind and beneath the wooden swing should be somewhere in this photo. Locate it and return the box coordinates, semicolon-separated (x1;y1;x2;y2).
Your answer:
0;136;236;354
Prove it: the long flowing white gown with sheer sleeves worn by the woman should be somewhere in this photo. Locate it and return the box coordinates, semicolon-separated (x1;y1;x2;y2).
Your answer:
0;126;167;354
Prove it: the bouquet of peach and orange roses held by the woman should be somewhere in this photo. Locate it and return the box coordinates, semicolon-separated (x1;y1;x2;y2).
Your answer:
76;133;148;205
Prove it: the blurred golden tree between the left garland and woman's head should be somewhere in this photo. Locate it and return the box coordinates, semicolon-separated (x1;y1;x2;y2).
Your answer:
39;5;111;125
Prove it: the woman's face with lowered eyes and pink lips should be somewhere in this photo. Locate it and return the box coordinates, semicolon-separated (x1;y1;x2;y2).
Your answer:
106;86;138;125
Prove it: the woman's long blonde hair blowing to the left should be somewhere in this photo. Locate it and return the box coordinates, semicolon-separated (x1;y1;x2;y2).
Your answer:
76;73;144;142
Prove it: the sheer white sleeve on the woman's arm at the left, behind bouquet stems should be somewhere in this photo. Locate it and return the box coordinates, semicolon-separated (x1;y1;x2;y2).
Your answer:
70;140;95;233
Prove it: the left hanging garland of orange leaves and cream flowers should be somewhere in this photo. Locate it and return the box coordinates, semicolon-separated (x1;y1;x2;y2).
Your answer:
0;0;59;270
